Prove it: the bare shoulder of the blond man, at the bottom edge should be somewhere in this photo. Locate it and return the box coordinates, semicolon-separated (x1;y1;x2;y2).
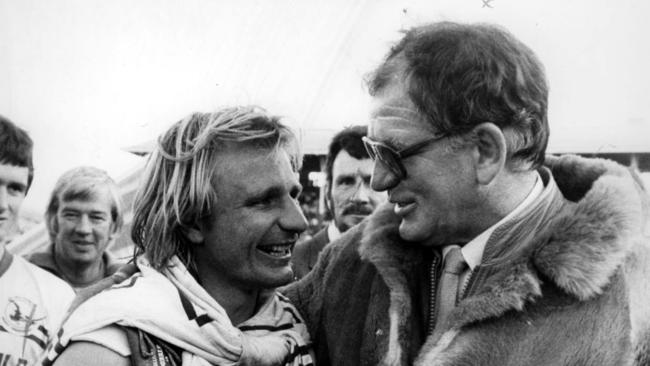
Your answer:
53;341;131;366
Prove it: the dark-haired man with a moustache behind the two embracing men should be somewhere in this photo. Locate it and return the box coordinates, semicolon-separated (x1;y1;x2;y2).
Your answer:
293;126;386;279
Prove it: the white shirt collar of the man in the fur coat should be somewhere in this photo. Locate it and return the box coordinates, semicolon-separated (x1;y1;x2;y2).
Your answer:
442;172;544;294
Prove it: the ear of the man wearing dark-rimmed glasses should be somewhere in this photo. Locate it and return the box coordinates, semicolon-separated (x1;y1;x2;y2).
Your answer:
473;122;508;185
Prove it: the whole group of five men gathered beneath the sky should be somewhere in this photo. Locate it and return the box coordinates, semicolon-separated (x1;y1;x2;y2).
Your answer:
0;22;650;366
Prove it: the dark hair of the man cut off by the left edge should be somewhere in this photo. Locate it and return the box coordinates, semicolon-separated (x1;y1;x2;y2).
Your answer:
0;115;34;190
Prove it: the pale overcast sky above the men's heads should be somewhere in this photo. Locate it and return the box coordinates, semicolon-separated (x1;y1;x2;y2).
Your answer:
0;0;650;212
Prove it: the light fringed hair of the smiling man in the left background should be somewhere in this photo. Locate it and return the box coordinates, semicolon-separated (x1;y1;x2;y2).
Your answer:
45;166;124;243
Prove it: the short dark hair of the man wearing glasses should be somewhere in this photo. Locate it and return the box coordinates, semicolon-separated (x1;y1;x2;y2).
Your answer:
368;22;549;168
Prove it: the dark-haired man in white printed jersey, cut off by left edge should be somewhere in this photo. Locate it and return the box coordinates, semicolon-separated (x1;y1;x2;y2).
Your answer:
0;116;74;366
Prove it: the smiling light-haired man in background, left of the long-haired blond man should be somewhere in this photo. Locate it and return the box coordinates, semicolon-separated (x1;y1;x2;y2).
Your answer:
29;167;123;289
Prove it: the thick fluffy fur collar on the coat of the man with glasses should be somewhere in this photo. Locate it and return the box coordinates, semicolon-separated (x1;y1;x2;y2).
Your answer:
359;156;642;364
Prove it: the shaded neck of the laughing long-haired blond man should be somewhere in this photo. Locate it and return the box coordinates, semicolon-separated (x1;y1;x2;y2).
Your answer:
198;268;260;325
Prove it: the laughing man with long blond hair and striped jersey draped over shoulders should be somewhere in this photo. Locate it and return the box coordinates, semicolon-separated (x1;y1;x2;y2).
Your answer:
46;107;311;365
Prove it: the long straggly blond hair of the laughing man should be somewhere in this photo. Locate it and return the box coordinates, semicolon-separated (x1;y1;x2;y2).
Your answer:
131;106;302;269
